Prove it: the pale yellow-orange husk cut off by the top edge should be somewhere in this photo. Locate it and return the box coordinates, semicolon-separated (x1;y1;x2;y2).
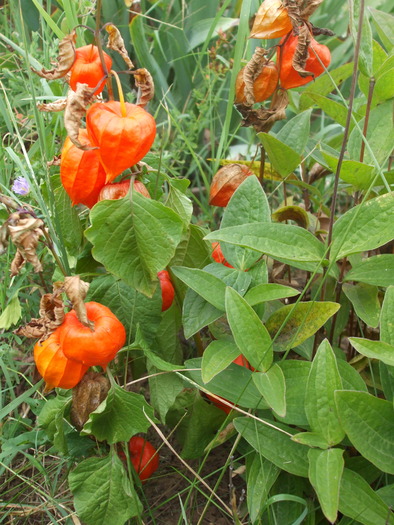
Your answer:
250;0;293;39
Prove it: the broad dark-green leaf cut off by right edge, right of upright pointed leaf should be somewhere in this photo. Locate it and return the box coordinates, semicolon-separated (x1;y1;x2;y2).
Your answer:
335;390;394;474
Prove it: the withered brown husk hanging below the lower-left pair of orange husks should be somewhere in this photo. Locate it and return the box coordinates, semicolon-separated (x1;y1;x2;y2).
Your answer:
70;370;110;430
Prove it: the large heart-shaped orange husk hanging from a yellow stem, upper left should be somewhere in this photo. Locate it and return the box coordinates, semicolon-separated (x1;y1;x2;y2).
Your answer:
86;100;156;182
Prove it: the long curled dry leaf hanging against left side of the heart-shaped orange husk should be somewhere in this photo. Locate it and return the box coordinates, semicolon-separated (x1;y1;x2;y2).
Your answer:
64;83;95;151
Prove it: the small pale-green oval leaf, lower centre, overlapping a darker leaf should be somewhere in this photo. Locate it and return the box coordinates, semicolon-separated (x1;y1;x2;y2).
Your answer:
201;339;240;383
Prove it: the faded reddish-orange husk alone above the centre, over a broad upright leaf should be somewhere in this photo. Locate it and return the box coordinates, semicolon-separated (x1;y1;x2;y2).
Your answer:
209;164;253;208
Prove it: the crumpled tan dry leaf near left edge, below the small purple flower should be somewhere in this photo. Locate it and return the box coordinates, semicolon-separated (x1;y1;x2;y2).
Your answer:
7;213;44;276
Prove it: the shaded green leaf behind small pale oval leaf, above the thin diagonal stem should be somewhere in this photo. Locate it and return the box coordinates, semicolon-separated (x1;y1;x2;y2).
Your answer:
183;358;267;409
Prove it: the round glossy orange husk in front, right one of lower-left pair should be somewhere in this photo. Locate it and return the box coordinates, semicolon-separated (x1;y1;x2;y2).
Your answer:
58;301;126;369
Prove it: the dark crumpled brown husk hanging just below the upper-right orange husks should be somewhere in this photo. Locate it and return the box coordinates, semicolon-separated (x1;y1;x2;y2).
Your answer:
237;88;289;133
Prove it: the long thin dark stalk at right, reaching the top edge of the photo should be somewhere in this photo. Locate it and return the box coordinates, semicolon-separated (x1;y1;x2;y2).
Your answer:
322;0;365;294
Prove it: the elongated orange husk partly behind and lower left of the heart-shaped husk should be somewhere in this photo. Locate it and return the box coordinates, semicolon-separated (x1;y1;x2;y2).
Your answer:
60;129;106;208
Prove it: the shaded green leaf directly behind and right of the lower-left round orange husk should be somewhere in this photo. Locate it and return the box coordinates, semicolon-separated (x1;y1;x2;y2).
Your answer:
87;275;162;343
